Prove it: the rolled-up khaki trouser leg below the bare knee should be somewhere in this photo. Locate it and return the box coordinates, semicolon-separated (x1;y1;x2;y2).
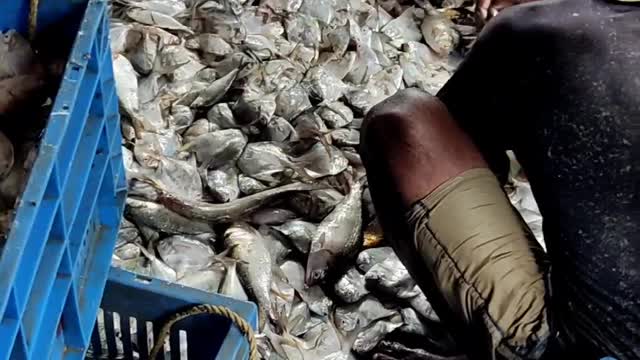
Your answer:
408;169;549;359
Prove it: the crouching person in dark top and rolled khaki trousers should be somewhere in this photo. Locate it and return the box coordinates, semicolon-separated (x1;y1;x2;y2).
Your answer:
360;0;640;360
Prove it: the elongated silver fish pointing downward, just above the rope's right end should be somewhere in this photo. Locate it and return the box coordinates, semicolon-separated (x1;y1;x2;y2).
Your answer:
225;223;273;329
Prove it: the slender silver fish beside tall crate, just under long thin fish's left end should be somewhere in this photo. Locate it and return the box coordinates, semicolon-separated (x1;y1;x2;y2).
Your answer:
126;198;213;234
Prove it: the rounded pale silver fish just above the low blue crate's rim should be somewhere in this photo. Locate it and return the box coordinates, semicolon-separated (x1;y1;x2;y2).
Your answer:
156;235;215;278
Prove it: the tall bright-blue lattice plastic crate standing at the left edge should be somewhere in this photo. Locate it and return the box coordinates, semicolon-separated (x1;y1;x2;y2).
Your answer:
0;0;126;360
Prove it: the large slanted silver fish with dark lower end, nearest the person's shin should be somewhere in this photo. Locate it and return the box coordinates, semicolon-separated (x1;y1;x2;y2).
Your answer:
305;176;362;285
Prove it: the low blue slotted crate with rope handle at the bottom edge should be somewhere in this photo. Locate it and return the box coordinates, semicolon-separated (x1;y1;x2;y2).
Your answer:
91;268;258;360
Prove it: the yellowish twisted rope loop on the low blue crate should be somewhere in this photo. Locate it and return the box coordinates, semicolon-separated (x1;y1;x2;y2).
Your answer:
149;305;260;360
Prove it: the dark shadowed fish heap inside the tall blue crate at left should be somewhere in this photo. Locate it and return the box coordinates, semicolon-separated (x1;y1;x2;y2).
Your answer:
0;29;66;245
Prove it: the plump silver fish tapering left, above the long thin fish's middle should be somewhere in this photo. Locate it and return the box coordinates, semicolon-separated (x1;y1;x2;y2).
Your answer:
182;129;247;168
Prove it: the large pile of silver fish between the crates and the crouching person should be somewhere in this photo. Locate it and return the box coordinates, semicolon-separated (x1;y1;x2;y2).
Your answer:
111;0;544;360
